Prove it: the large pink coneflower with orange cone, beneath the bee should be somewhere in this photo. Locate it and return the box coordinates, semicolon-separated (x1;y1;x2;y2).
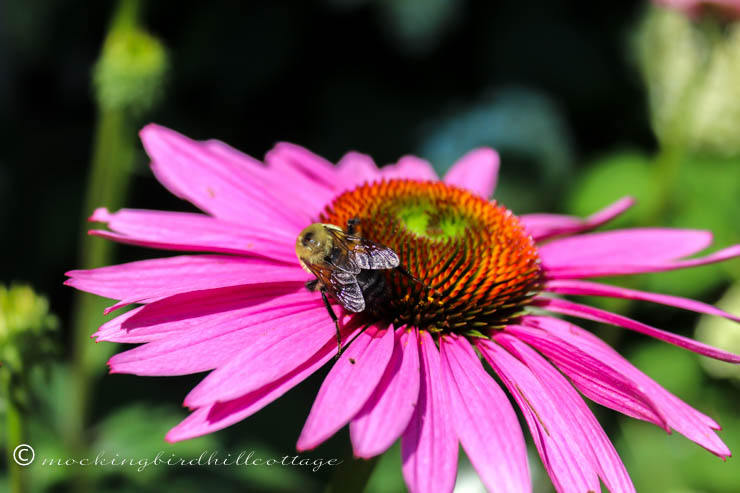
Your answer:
67;125;740;493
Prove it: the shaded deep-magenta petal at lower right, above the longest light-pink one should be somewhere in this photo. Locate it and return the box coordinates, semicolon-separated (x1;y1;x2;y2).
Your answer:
506;325;670;431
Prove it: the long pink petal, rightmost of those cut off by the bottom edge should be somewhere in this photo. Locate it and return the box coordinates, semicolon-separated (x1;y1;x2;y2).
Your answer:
496;333;635;493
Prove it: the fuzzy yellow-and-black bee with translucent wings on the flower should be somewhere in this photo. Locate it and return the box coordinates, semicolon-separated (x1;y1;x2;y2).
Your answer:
295;218;410;355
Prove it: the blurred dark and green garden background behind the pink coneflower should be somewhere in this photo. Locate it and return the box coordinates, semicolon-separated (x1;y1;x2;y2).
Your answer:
0;0;740;493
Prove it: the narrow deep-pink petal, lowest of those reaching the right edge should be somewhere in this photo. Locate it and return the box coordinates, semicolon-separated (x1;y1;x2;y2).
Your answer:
534;298;740;363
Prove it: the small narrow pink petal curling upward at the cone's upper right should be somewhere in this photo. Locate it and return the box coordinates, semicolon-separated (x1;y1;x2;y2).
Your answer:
519;197;635;241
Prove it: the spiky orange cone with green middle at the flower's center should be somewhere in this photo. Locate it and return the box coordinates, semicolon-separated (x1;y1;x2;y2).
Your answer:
320;180;541;336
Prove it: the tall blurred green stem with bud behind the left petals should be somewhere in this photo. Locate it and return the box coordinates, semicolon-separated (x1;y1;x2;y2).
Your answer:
64;0;166;492
